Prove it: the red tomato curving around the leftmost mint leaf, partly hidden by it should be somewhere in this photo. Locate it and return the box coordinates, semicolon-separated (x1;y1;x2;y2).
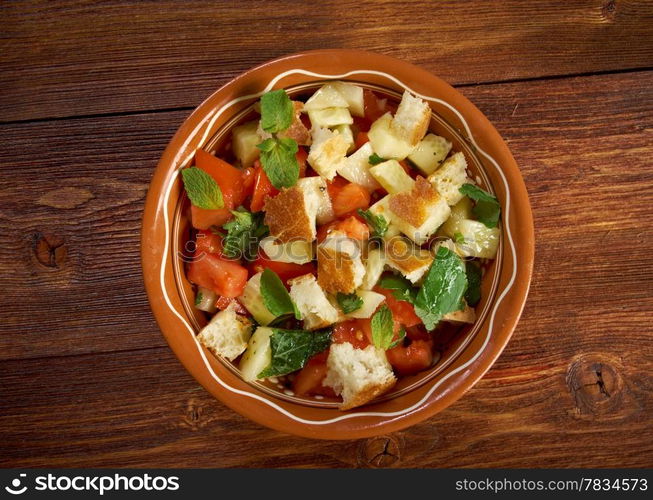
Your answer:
191;149;245;229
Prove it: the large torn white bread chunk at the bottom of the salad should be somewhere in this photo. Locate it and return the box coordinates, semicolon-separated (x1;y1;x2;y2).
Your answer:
323;342;397;410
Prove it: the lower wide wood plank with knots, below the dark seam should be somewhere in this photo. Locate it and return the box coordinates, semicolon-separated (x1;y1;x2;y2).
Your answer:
0;68;653;467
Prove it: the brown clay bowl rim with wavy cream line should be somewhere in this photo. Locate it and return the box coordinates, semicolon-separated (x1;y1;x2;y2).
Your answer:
141;49;534;439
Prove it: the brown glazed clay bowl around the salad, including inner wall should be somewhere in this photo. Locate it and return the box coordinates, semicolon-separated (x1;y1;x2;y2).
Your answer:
141;50;534;439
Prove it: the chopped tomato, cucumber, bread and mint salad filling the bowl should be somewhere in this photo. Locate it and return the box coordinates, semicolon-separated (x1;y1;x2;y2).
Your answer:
181;80;501;411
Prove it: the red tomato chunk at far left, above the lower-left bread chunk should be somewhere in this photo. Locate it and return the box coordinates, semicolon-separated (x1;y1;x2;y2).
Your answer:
187;254;247;297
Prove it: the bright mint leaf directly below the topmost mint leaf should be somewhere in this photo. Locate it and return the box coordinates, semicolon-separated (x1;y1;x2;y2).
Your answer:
256;137;299;189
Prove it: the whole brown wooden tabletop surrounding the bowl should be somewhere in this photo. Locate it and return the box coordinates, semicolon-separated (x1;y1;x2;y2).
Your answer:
0;0;653;467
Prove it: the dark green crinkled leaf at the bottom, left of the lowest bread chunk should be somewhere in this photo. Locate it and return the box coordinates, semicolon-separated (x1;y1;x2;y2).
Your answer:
258;328;331;378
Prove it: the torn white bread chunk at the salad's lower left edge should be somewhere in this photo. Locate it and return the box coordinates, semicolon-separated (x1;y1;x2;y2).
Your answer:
197;302;252;361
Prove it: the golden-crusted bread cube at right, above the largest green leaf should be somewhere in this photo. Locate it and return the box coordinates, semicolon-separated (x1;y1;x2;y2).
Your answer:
388;177;451;245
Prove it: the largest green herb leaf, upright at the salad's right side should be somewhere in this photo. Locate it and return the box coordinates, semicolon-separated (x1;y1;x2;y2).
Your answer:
415;247;467;330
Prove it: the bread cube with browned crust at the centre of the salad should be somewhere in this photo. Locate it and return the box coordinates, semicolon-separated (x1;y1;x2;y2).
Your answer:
317;231;365;295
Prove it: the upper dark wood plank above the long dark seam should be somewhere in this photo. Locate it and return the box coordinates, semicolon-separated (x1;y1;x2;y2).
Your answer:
0;0;653;121
